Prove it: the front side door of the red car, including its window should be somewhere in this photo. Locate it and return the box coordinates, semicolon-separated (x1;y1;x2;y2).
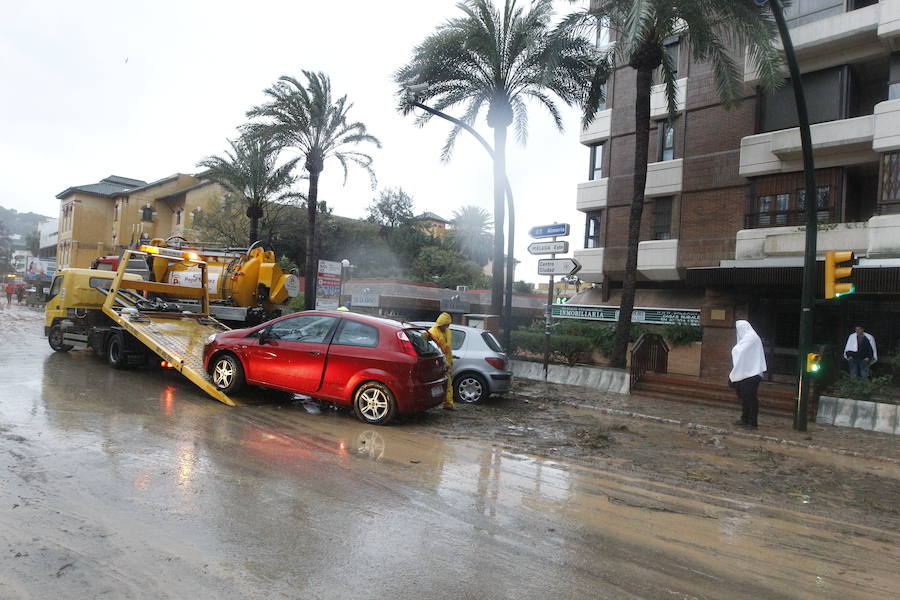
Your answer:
248;315;338;394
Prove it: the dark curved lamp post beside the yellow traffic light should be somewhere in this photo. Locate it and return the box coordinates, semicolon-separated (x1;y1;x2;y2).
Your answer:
756;0;818;431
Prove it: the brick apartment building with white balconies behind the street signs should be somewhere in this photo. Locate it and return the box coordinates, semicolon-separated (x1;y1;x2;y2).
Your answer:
572;0;900;380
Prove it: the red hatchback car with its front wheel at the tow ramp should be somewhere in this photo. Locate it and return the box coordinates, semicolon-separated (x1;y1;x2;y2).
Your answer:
203;311;447;425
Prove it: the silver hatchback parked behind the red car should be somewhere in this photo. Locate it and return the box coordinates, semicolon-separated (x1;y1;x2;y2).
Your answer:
414;322;512;402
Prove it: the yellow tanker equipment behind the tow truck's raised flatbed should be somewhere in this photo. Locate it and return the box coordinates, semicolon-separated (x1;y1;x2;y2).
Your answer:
149;238;300;320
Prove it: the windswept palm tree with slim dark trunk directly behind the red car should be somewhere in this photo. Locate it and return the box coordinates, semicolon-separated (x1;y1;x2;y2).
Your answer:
247;71;381;310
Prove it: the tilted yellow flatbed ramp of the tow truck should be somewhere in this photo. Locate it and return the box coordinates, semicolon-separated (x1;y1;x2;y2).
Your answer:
103;250;235;406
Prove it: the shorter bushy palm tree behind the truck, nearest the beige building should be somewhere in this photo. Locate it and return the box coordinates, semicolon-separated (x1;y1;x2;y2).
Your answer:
197;134;299;247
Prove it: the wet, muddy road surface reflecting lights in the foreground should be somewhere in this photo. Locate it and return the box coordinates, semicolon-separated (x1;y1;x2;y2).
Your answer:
0;309;900;599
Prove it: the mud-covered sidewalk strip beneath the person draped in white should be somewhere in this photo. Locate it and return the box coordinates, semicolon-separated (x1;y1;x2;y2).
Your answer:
513;380;900;464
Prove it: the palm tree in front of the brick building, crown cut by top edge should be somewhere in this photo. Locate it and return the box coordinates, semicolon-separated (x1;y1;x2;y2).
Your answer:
557;0;783;368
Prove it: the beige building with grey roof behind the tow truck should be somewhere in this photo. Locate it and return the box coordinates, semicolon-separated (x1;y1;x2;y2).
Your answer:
56;173;224;268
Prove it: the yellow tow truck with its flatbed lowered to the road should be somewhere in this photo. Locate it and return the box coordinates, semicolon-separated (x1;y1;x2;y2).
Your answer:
44;246;234;406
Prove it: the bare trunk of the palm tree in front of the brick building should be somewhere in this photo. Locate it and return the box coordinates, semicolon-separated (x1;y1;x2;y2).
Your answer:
609;67;653;369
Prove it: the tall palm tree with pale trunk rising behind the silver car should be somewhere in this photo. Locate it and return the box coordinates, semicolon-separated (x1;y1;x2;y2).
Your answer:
395;0;593;314
